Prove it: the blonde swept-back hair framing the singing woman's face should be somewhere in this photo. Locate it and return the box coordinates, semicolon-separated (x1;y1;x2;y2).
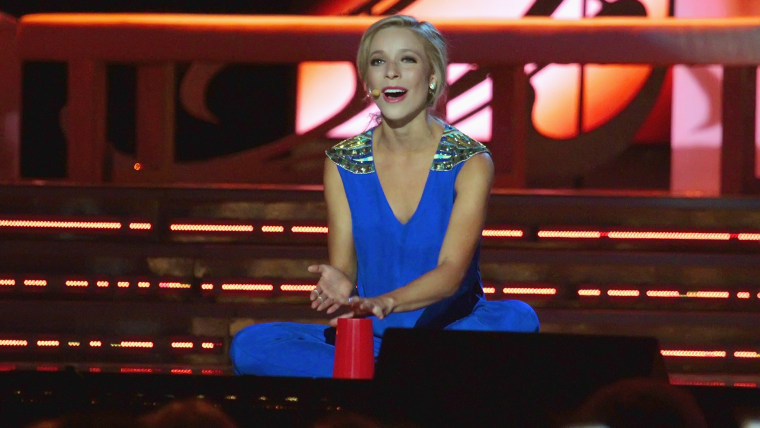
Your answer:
356;15;448;107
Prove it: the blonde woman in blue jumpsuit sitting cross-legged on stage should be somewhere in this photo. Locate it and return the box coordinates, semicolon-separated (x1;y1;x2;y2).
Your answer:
231;15;538;377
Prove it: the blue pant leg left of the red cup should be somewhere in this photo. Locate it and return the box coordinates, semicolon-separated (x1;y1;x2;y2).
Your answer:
230;322;335;377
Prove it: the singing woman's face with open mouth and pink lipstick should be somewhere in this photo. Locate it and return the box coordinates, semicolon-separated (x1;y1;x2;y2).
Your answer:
365;27;435;122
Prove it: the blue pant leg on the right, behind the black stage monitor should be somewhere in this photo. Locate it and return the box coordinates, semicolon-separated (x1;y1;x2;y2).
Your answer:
445;300;539;333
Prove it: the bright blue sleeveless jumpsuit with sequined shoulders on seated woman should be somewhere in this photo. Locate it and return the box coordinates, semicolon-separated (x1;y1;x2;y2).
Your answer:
230;126;538;377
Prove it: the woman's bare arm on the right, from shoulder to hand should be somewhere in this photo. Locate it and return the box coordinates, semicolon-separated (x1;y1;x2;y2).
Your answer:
336;154;493;318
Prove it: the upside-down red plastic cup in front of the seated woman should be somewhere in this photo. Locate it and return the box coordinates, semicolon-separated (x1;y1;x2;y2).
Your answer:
333;318;375;379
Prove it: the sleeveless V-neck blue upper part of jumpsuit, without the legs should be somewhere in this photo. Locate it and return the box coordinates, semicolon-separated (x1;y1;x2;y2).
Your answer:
326;125;488;336
